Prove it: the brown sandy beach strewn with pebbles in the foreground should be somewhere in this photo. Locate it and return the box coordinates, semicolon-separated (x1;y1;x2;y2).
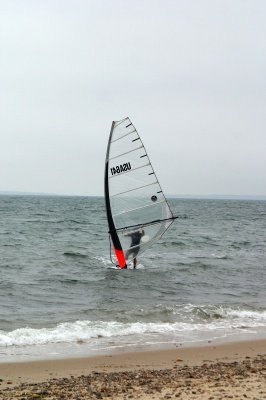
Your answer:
0;340;266;400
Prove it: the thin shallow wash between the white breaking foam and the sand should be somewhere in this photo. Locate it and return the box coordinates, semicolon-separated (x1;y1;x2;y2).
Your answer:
0;328;266;365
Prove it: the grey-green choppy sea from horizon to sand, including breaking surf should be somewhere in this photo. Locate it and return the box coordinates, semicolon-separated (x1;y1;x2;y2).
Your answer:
0;195;266;362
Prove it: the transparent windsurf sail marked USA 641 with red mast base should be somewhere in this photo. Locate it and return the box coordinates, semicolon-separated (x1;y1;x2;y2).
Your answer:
104;118;176;268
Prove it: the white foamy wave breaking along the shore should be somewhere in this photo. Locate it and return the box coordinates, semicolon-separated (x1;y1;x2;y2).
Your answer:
0;305;266;347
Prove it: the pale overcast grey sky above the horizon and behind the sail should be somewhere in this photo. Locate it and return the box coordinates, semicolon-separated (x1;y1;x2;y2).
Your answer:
0;0;266;195
